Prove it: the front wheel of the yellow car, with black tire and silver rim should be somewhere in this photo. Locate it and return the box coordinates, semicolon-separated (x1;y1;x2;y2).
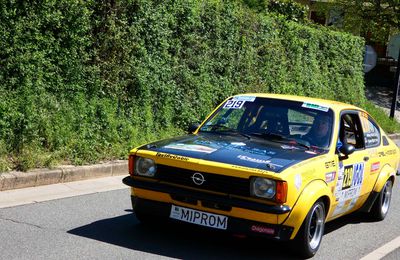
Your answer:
294;200;325;258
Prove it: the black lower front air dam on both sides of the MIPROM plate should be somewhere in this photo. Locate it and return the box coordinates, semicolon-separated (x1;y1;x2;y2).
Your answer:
131;196;293;241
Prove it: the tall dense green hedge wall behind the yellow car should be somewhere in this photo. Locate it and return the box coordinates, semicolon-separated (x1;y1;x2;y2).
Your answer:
0;0;364;172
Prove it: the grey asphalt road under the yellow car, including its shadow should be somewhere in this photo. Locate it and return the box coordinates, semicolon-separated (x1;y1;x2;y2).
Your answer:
0;179;400;260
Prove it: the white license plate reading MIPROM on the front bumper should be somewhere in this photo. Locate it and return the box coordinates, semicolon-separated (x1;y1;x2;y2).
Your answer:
169;205;228;230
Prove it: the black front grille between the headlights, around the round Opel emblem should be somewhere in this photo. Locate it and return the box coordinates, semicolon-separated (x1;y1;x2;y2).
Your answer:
157;165;250;196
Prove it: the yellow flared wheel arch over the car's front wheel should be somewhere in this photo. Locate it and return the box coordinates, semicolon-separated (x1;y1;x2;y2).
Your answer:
283;180;332;239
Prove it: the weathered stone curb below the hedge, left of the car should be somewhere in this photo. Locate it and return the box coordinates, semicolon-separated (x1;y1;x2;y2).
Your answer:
0;160;128;191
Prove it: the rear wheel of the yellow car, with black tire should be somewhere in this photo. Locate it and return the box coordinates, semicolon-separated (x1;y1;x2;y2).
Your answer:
370;179;393;221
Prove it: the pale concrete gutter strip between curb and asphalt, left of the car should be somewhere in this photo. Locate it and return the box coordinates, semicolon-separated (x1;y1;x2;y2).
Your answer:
0;176;129;208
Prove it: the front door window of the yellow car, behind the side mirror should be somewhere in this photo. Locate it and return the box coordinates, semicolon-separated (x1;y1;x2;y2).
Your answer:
339;113;364;149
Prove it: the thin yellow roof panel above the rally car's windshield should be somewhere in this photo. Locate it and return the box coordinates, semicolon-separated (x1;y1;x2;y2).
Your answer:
235;93;366;112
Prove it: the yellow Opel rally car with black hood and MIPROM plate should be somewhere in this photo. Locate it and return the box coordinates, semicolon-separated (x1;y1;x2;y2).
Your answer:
123;94;399;257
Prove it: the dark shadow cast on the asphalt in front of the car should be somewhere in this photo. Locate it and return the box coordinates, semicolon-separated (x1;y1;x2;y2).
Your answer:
68;210;296;259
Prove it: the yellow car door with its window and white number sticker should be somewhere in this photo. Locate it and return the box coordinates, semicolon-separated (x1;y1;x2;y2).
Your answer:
332;110;371;217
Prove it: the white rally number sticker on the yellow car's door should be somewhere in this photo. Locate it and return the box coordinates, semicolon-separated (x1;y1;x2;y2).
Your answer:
335;162;364;202
